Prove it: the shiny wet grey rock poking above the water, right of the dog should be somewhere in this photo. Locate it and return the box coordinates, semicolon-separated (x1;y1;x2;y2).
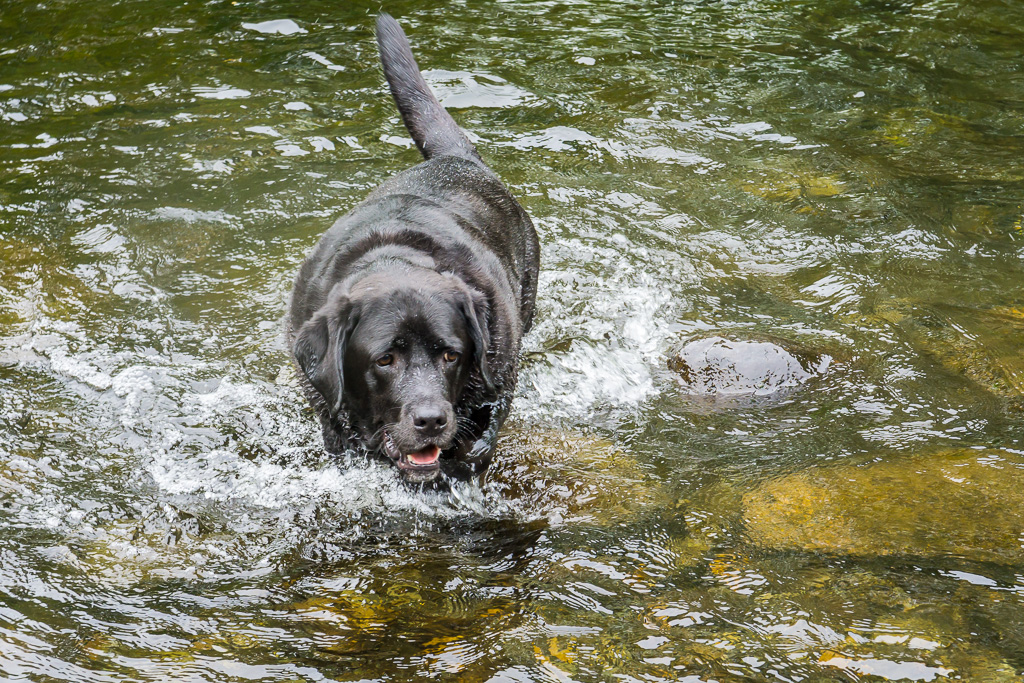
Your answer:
669;337;831;395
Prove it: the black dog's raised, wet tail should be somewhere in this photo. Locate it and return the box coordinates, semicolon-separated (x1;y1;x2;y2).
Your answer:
377;12;480;163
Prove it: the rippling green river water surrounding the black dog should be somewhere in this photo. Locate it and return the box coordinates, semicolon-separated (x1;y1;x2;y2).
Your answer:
0;0;1024;683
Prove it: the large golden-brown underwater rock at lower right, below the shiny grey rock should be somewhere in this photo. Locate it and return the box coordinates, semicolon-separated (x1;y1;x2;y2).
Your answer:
743;450;1024;562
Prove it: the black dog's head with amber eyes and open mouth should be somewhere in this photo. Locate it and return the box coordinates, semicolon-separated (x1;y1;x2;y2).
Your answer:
294;270;494;481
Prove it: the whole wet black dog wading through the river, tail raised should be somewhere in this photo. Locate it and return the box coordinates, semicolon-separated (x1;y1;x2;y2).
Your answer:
289;13;540;481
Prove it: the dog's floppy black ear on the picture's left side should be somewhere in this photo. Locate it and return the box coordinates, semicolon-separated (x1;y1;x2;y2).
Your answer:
292;293;358;417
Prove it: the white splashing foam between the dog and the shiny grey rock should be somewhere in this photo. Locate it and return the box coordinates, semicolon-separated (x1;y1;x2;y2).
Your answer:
516;229;693;423
